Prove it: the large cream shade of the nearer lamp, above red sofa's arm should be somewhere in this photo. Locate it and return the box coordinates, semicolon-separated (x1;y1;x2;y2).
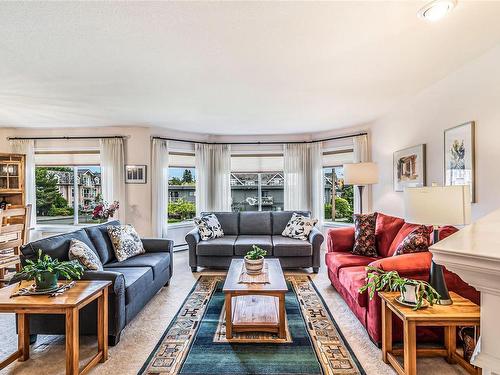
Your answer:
404;185;471;225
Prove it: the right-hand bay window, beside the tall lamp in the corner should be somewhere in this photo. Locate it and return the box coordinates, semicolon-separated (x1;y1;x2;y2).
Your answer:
323;166;354;223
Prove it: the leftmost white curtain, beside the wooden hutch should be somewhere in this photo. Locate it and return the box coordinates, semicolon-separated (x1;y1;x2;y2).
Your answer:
10;139;36;228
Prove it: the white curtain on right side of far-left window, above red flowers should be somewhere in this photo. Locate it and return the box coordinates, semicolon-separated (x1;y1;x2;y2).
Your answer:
100;138;127;223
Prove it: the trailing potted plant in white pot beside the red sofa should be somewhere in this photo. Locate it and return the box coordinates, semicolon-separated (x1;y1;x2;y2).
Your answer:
359;266;441;310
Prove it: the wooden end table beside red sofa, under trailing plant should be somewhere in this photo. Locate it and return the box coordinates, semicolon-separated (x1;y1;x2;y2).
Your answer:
379;292;481;375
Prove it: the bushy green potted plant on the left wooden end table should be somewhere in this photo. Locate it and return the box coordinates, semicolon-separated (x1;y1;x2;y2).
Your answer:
14;250;83;291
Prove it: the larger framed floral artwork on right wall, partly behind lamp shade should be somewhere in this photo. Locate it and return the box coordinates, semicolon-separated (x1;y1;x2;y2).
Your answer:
444;121;476;203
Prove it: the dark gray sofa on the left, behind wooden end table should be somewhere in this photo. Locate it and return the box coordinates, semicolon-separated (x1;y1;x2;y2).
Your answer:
16;221;173;345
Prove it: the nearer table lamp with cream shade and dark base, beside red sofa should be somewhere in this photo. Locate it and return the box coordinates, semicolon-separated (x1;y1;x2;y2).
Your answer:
404;185;471;305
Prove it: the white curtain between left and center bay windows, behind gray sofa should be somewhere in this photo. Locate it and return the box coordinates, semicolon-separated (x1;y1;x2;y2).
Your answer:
195;143;231;216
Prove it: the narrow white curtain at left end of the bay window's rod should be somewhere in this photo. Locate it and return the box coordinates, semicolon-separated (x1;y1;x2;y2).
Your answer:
151;139;168;237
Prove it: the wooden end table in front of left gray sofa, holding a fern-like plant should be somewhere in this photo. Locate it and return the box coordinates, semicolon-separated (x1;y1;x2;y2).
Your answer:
0;281;111;375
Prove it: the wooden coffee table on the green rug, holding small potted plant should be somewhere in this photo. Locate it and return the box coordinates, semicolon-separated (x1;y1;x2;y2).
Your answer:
223;259;288;339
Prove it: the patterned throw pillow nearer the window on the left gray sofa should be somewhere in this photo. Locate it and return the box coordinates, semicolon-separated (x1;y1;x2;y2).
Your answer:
106;225;146;262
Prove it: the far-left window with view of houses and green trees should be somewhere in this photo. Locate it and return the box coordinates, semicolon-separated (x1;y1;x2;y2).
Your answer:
35;165;102;225
